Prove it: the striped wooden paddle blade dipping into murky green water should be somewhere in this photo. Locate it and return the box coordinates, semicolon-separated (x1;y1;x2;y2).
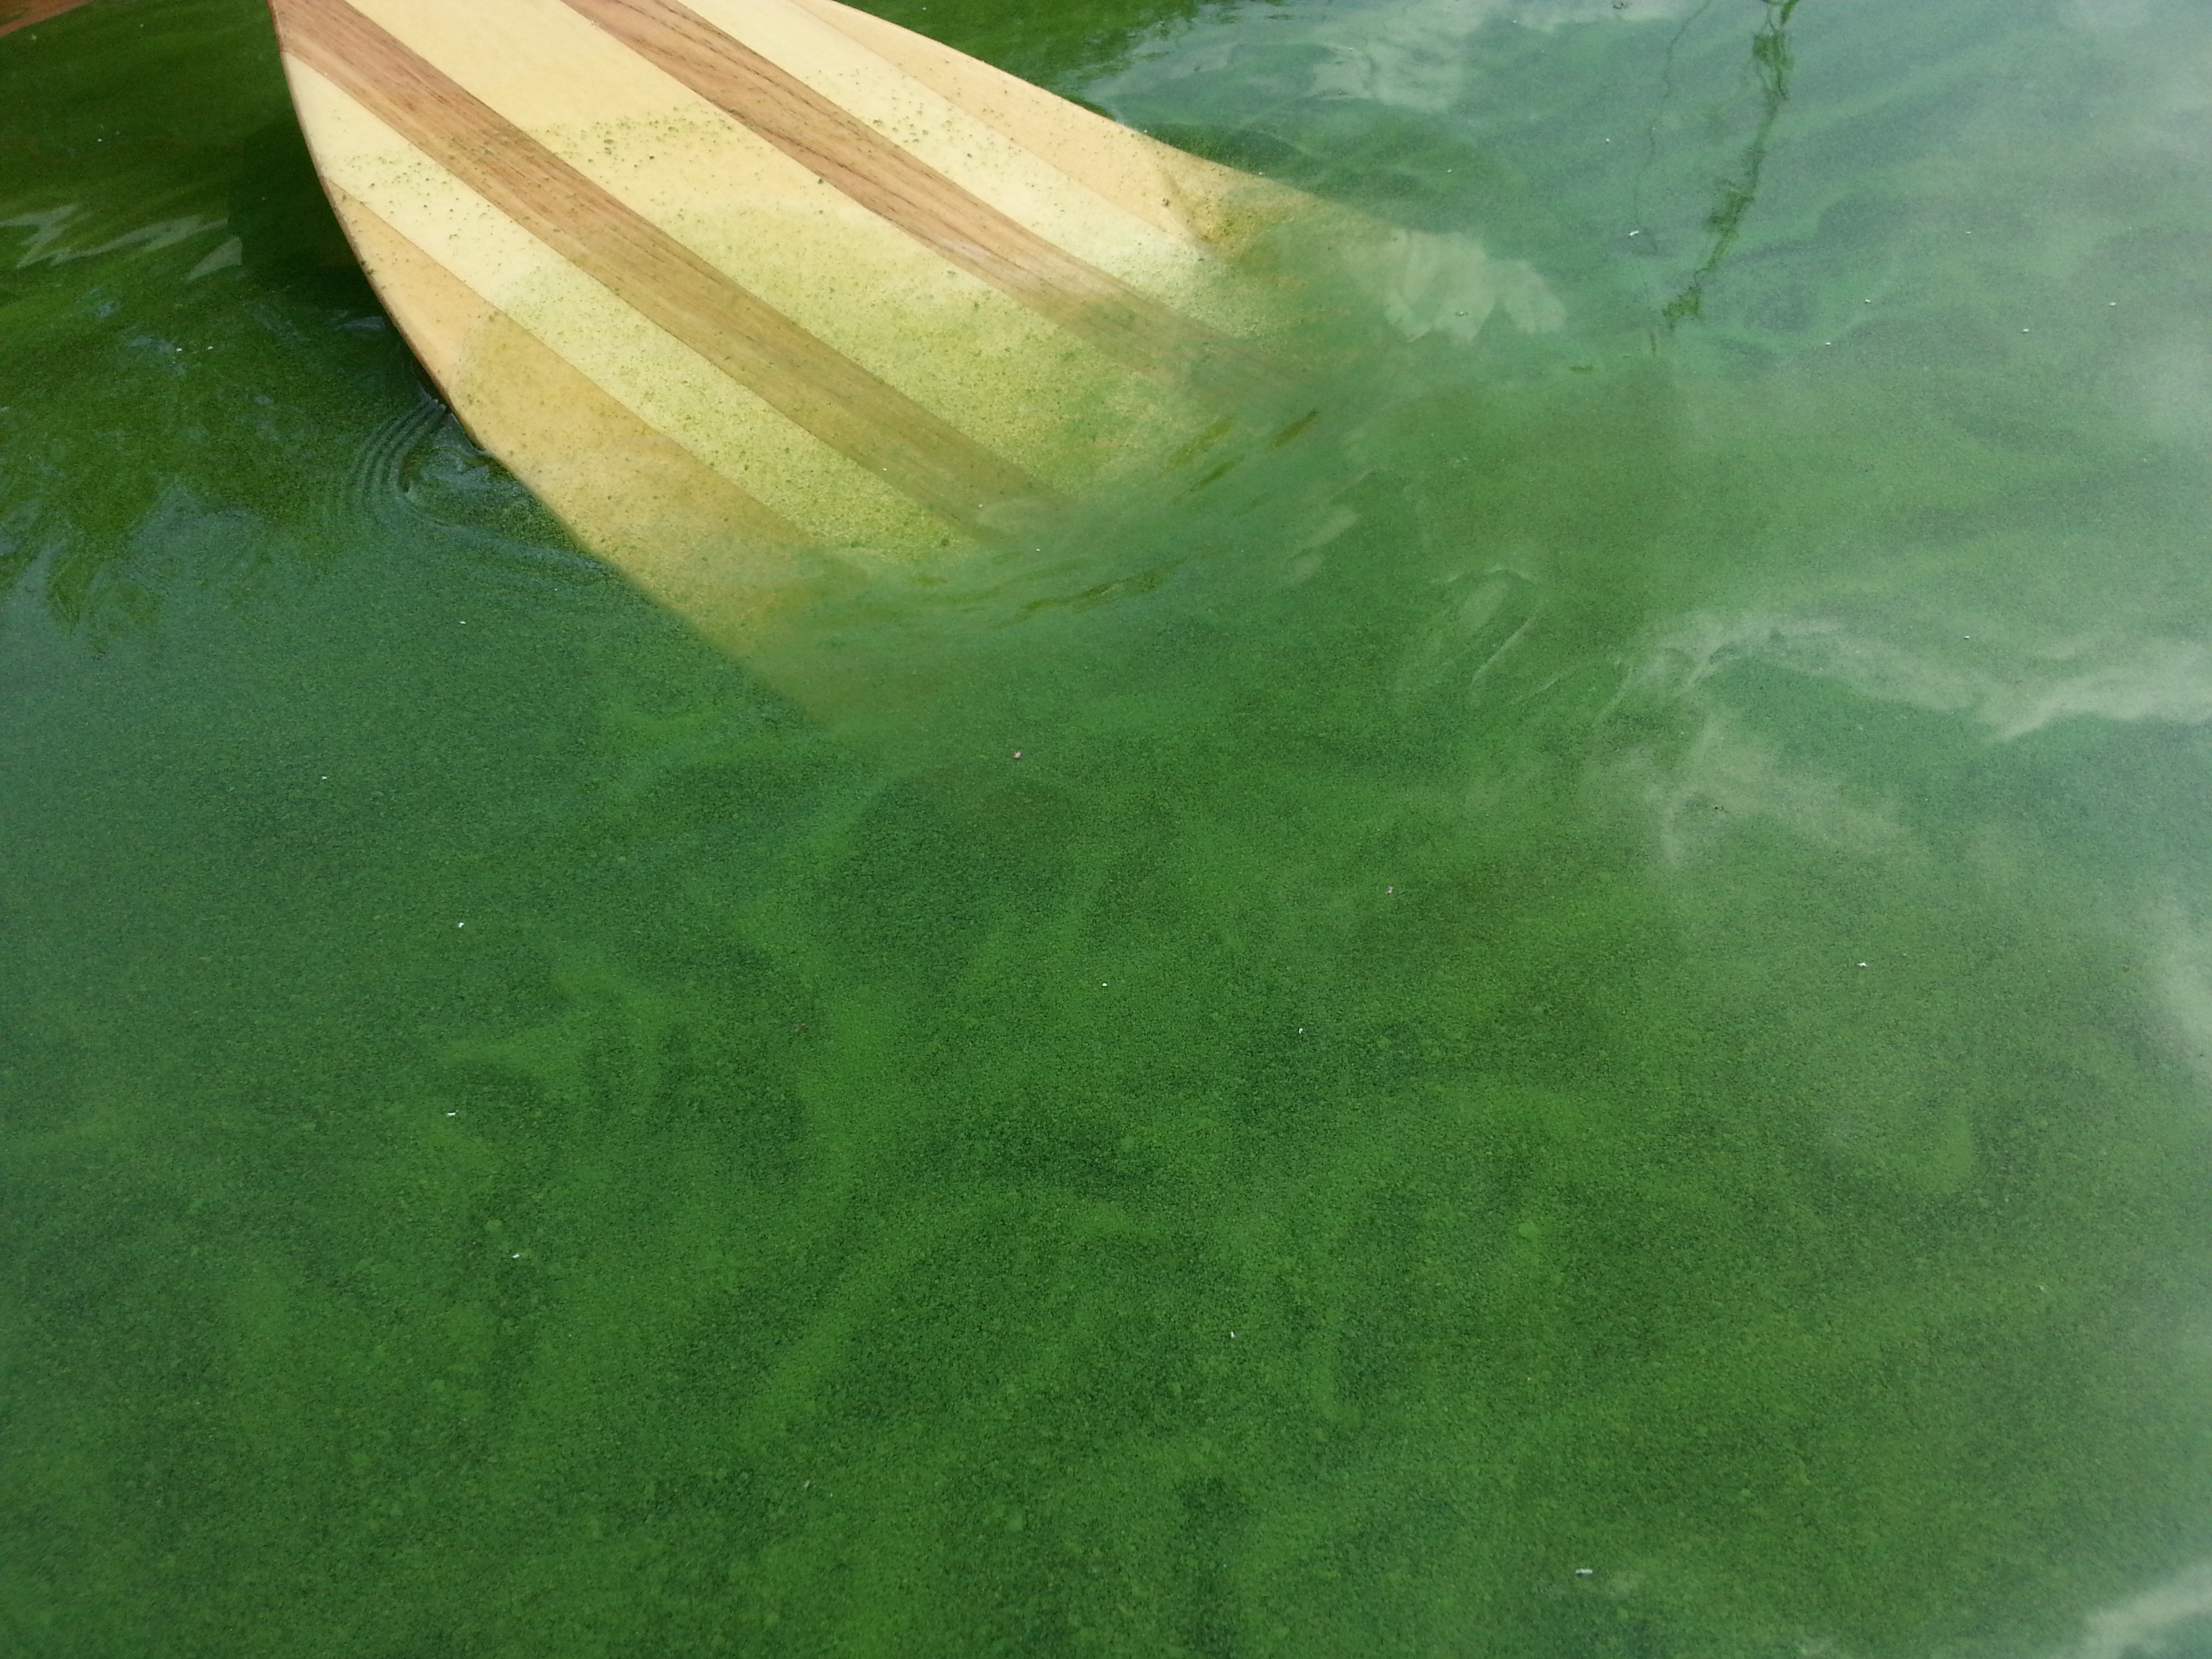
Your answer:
272;0;1305;646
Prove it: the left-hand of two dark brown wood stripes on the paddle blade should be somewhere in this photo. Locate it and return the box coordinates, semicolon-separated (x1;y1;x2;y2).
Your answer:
274;0;1046;531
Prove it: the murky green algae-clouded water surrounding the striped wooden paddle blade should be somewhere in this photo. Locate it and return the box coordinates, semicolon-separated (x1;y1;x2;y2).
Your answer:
0;0;2212;1659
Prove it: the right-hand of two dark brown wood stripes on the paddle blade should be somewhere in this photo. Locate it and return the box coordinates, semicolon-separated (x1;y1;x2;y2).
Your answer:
569;0;1241;389
